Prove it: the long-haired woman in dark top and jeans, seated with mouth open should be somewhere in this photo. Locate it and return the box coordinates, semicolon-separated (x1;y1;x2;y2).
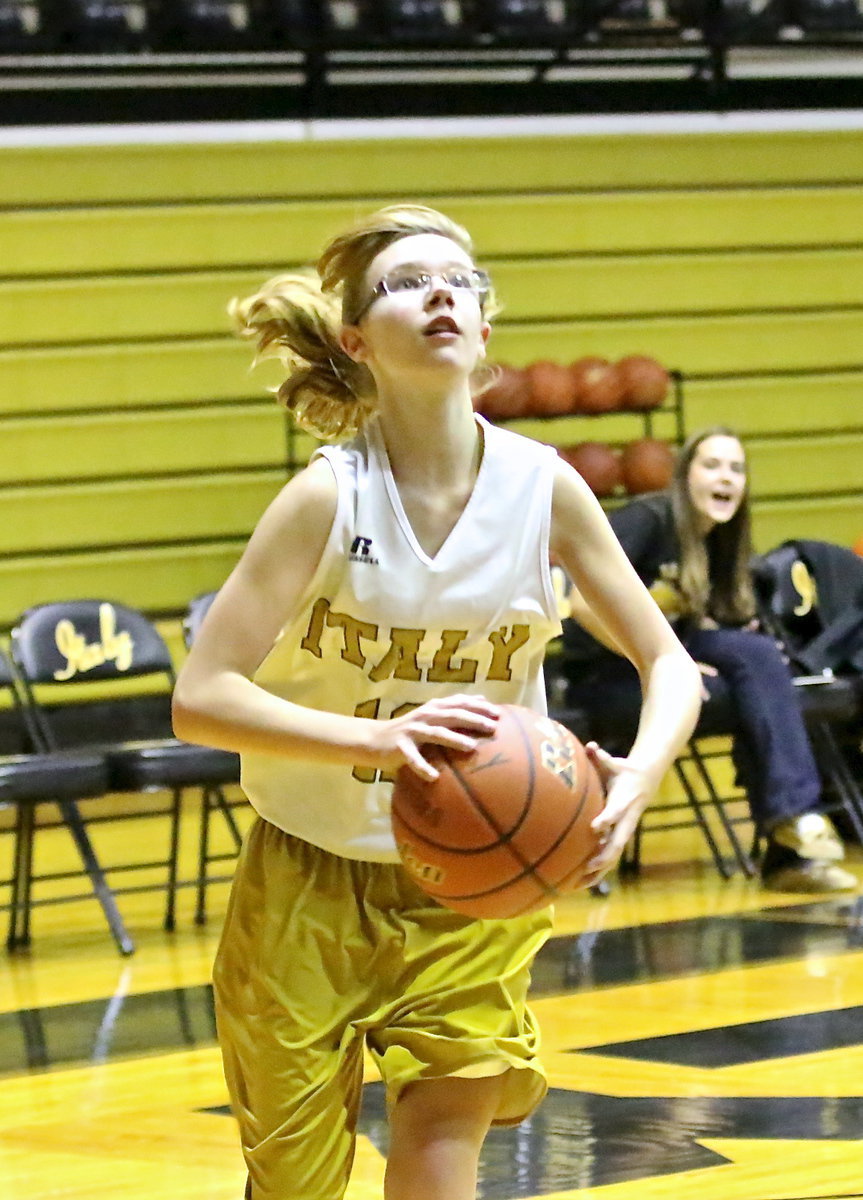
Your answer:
564;426;858;892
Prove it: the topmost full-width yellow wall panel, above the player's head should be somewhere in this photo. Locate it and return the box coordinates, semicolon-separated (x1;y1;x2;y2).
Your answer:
0;127;863;204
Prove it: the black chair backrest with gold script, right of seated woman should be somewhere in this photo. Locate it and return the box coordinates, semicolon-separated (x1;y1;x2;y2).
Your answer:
753;540;863;672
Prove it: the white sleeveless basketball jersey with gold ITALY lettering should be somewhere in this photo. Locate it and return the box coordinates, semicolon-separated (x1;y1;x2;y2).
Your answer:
242;416;561;862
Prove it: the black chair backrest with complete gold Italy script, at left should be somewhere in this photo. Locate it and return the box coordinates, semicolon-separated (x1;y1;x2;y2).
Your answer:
11;599;174;749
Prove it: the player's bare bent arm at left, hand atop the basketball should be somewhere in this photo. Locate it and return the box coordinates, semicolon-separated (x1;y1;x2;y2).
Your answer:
173;461;497;779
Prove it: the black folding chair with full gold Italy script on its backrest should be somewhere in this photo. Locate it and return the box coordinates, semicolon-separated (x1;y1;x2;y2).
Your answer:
11;599;242;930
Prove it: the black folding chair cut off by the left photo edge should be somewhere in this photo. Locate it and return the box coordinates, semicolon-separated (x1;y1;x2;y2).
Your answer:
0;653;127;954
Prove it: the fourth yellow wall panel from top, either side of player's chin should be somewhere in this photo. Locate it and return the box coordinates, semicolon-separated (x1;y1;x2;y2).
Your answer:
0;310;863;414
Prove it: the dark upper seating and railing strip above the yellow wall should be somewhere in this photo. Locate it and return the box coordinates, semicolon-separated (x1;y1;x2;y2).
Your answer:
0;0;863;125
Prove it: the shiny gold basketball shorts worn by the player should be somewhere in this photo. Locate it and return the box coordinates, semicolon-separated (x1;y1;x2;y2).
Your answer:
214;820;551;1200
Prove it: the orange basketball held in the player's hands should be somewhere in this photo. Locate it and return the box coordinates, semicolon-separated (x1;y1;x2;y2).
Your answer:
392;704;605;918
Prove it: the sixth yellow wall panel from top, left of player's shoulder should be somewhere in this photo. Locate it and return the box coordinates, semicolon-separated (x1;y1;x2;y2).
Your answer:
0;470;286;554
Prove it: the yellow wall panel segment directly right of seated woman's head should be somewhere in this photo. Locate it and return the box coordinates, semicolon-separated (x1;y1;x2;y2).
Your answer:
748;434;863;499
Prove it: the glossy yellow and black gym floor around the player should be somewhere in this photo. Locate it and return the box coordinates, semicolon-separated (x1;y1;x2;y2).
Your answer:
0;814;863;1200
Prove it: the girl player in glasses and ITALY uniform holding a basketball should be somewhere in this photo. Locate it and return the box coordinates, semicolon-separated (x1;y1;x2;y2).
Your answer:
174;206;700;1200
